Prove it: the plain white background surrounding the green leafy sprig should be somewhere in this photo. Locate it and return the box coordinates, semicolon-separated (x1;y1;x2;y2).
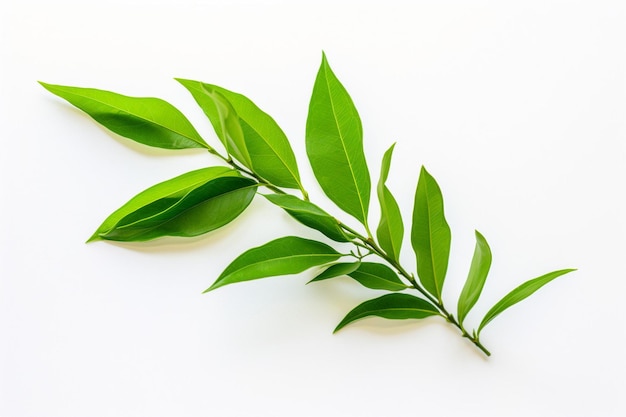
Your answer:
0;0;626;417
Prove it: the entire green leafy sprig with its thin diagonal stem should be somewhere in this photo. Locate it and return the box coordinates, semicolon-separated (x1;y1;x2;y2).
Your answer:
41;55;574;356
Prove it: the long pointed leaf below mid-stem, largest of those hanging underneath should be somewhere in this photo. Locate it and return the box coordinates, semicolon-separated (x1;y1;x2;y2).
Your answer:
205;236;342;292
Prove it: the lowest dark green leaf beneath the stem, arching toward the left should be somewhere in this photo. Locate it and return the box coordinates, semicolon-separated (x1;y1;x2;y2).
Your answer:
334;294;439;332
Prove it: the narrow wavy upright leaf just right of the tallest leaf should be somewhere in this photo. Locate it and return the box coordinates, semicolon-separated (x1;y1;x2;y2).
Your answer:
376;144;404;261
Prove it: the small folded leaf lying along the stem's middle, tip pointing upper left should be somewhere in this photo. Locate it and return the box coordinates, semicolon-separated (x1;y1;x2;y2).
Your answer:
263;194;350;242
